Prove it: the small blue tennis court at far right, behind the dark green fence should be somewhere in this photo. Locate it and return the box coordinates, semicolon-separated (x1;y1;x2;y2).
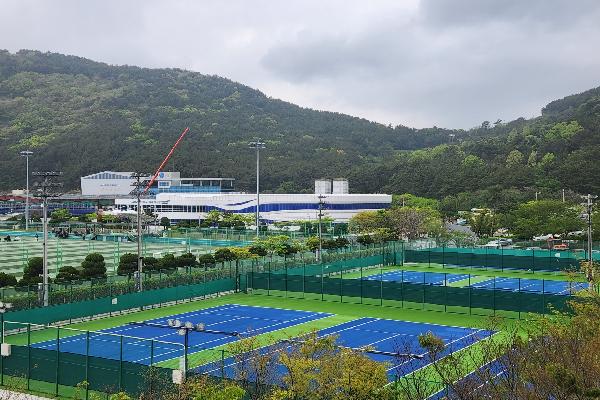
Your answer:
471;278;589;294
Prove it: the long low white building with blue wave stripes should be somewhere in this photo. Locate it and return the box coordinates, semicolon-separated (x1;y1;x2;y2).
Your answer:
115;193;392;222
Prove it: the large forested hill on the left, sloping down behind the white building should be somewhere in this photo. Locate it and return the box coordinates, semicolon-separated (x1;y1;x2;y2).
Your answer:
0;51;460;190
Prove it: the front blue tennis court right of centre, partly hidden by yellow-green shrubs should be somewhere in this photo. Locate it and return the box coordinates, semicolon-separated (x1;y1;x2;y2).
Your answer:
195;318;494;380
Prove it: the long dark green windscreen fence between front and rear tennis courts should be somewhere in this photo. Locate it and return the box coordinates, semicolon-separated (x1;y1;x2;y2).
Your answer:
246;271;574;317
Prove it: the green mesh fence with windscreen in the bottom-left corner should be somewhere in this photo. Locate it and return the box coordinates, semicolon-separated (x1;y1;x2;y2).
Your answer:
0;322;174;398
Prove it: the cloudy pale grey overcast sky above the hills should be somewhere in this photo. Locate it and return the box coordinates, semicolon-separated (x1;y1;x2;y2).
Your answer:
0;0;600;128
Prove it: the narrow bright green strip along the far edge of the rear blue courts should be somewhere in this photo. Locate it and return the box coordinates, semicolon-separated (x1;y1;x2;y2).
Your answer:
342;263;585;282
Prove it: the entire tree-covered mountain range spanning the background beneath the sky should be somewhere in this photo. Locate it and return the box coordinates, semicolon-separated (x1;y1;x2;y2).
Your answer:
0;50;600;209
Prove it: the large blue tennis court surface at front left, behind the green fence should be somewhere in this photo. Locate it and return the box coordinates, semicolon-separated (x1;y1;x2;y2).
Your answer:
32;304;331;365
